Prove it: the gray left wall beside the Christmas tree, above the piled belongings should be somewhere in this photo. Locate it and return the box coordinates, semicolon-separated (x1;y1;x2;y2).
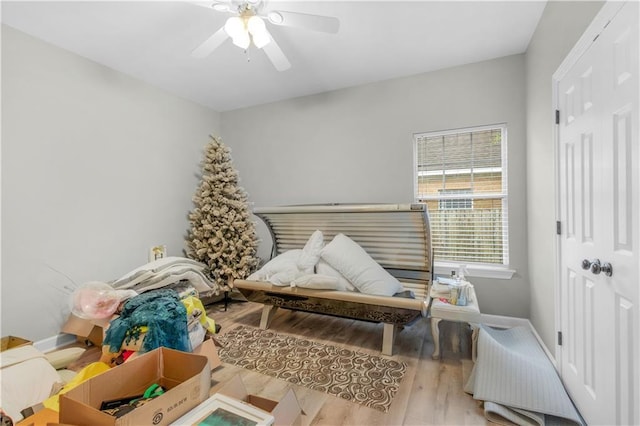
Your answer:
1;25;220;341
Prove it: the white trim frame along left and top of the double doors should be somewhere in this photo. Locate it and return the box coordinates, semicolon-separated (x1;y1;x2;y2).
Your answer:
550;0;634;376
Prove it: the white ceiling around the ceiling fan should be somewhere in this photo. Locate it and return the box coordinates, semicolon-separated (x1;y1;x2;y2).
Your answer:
1;0;545;112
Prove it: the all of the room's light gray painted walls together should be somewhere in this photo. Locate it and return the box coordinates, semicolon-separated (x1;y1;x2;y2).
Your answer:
0;1;602;348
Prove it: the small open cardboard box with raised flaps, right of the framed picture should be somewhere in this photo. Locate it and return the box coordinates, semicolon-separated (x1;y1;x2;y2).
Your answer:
218;375;305;426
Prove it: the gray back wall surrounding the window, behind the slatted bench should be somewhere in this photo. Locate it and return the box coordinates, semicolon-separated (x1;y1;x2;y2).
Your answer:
222;55;529;318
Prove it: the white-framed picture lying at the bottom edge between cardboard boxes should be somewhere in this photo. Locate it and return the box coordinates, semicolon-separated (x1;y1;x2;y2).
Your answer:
173;393;275;426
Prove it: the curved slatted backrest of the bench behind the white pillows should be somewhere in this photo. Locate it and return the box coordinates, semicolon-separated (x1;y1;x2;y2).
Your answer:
254;204;433;297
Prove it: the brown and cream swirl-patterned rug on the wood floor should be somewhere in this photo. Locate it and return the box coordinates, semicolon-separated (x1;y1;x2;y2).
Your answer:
216;326;407;412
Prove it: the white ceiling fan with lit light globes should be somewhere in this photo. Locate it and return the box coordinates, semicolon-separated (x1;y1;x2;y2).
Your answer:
191;0;340;71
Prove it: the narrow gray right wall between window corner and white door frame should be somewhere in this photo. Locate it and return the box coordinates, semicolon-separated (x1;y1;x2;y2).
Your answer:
526;1;603;352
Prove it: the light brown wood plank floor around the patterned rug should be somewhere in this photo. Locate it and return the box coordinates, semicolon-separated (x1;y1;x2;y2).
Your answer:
73;296;491;426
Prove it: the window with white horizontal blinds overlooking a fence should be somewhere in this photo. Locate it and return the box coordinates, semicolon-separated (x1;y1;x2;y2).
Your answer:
414;125;509;265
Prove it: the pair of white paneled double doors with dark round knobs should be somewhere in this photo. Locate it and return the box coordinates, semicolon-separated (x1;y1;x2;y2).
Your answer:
556;1;640;425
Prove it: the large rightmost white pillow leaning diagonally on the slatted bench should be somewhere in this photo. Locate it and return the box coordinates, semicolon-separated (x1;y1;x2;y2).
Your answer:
322;234;404;296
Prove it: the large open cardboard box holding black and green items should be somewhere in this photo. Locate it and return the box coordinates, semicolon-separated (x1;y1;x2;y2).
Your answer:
59;348;211;426
